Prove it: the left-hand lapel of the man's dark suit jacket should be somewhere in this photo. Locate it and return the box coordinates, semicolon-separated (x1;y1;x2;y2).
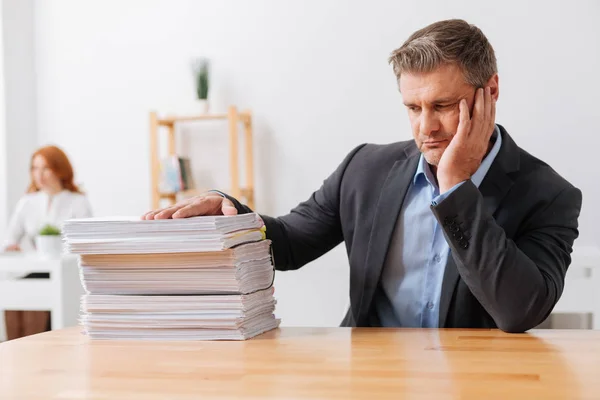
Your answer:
355;146;420;326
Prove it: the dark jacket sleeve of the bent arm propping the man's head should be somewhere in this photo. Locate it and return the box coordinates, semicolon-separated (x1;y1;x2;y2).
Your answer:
432;180;582;332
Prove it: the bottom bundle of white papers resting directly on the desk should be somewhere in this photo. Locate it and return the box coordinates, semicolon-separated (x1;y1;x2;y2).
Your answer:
81;288;279;340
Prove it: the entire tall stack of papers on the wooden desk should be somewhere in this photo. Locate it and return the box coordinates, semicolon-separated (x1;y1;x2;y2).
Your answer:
63;214;280;340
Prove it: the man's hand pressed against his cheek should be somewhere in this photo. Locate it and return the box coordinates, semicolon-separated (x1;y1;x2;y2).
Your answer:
437;87;496;193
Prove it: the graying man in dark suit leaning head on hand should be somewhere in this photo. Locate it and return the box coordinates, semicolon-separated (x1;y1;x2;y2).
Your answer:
144;20;582;332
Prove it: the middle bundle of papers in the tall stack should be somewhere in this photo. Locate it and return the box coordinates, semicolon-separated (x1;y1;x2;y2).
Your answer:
79;240;274;294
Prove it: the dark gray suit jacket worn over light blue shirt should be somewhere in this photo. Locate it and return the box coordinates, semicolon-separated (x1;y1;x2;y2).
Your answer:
232;126;582;332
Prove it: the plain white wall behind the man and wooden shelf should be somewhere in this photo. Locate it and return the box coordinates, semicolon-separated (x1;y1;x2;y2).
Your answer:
30;0;600;325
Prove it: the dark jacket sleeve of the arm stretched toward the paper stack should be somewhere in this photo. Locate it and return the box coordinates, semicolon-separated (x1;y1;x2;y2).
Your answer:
226;144;364;270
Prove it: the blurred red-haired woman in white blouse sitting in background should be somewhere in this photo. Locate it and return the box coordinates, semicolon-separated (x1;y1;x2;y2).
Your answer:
4;146;92;340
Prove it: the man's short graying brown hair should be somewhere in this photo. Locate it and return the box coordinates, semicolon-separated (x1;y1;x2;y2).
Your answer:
389;19;498;88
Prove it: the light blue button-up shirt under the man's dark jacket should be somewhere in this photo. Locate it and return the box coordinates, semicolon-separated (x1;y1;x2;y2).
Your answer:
375;126;502;328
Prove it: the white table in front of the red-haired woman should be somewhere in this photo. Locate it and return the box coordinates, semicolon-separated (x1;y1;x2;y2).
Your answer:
0;253;84;338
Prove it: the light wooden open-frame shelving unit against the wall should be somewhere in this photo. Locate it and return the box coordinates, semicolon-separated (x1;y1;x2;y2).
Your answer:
150;106;254;209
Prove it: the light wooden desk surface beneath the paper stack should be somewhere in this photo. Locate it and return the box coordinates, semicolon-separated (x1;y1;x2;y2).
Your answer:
0;328;600;400
